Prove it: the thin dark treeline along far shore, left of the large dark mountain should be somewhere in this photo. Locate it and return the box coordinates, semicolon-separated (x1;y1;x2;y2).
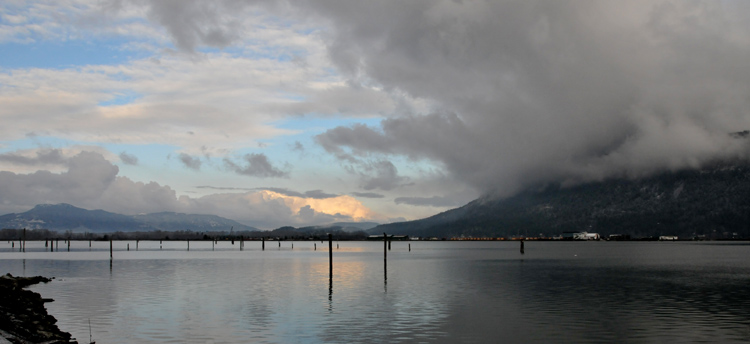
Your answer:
0;227;367;240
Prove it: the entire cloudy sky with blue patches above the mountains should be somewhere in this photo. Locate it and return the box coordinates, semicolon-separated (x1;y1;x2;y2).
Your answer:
0;0;750;229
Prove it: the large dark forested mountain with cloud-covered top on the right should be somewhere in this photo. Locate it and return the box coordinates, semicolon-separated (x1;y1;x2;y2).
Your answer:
368;163;750;238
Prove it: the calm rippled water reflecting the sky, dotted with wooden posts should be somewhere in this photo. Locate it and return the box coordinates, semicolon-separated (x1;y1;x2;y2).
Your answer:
0;241;750;343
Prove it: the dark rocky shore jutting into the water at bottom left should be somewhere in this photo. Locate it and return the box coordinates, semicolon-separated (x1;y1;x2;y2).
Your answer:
0;274;77;344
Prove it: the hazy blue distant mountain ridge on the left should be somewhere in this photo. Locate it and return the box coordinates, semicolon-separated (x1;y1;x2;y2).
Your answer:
0;203;258;233
